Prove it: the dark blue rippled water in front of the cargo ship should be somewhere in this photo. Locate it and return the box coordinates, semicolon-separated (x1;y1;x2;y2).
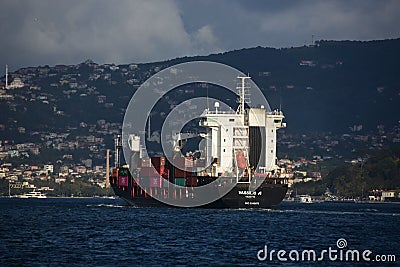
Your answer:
0;198;400;266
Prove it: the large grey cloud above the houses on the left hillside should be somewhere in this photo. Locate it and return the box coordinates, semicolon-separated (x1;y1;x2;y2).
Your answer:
0;0;191;70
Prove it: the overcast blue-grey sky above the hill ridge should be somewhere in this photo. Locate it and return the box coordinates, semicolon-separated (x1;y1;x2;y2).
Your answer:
0;0;400;74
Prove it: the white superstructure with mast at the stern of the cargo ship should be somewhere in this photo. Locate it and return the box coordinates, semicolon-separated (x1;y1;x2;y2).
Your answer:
200;77;286;178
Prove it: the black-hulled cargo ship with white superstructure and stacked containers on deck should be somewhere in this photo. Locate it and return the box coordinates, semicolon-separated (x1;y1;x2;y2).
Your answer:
109;76;288;209
